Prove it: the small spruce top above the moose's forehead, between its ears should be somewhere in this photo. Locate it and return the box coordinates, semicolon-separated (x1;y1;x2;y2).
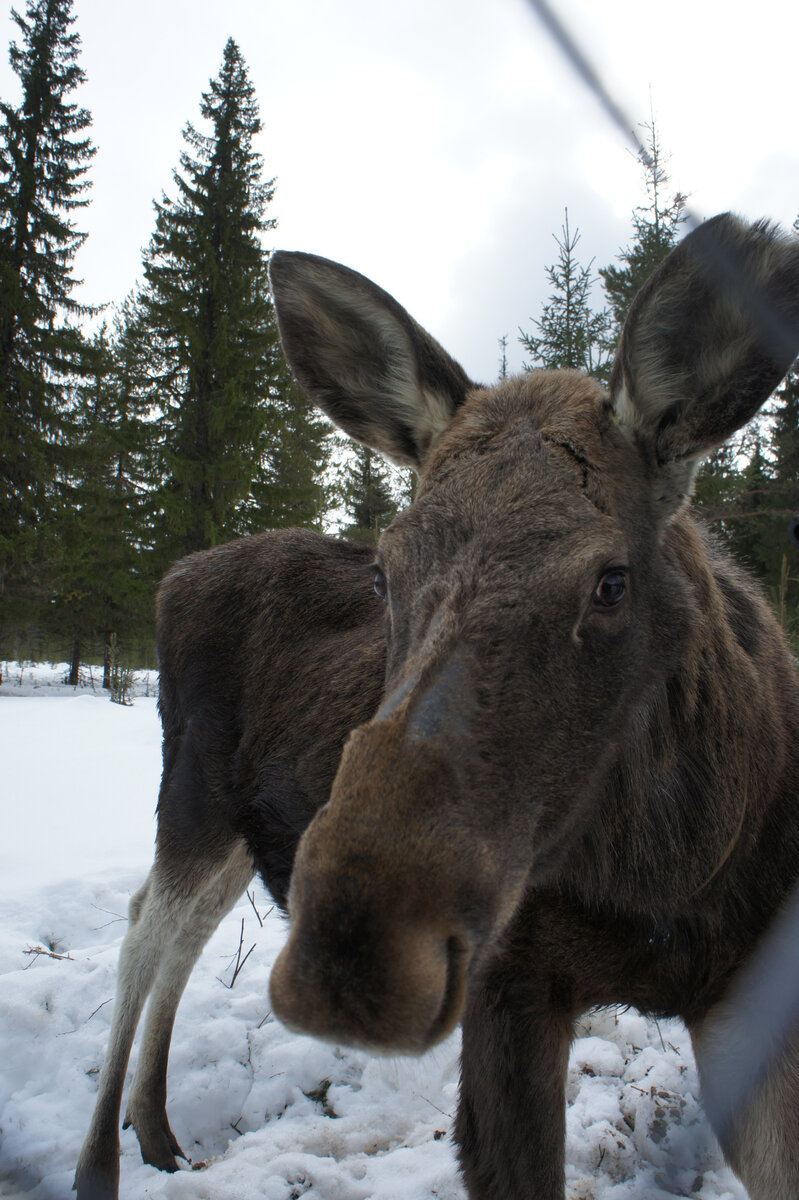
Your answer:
519;209;609;379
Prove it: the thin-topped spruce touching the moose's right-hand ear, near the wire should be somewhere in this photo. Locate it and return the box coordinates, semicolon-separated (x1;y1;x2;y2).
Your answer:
599;120;686;342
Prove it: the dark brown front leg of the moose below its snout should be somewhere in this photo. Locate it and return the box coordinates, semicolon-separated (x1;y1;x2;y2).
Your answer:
455;948;573;1200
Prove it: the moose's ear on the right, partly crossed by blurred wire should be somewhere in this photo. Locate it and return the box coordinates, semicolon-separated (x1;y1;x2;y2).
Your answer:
611;214;799;517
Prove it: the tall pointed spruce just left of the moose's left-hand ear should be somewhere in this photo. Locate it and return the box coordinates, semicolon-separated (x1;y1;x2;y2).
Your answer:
142;38;278;565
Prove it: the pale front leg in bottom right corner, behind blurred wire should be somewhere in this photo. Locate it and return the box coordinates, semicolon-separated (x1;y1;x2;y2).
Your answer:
690;1001;799;1200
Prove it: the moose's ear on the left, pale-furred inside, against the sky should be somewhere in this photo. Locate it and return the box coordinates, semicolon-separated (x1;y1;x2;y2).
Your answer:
269;251;474;469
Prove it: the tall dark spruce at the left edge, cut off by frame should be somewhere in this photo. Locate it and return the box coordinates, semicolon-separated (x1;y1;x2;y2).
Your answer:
0;0;95;648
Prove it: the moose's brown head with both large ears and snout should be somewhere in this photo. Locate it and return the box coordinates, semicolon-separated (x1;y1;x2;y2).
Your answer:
271;216;799;1052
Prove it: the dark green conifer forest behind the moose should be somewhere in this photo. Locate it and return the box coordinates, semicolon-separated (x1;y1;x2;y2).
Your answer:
0;0;799;682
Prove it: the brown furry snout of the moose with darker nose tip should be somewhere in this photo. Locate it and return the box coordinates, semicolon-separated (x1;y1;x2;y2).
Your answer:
270;721;484;1054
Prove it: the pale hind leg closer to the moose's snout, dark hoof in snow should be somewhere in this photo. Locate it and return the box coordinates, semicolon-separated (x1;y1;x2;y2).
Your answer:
124;842;253;1171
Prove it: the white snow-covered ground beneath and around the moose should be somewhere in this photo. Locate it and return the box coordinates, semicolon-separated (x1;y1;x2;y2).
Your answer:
0;665;746;1200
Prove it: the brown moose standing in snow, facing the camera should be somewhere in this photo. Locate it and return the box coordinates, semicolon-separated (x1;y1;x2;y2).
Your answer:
76;215;799;1200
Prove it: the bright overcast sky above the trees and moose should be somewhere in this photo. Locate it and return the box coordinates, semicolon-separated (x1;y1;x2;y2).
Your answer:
0;0;799;382
